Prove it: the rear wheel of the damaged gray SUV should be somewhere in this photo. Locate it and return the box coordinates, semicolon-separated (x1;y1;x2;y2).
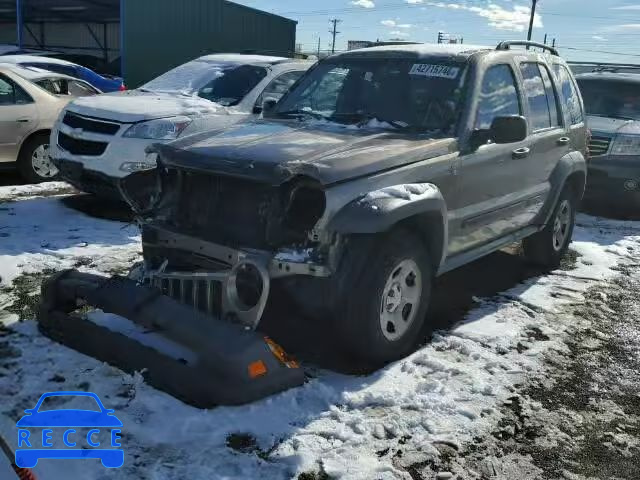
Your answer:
522;186;577;270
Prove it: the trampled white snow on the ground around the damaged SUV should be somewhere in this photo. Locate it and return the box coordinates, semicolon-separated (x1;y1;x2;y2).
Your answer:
0;182;640;480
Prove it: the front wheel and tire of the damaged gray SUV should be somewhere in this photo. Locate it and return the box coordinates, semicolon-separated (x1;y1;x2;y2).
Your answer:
336;229;433;366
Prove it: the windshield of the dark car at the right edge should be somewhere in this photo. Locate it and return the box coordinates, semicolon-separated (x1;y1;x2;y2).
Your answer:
577;78;640;120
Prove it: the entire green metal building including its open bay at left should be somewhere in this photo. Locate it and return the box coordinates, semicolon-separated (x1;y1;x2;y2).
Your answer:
0;0;296;88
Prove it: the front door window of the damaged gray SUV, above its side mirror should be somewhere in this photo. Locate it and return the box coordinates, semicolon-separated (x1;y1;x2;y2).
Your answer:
475;64;522;130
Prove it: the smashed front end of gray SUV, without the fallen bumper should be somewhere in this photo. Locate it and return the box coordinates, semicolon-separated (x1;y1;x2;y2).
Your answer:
121;150;335;329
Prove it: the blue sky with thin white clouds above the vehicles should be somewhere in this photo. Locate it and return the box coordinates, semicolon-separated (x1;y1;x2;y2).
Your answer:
234;0;640;63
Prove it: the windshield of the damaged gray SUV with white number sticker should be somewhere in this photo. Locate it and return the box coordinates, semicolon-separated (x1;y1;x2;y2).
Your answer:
274;58;464;132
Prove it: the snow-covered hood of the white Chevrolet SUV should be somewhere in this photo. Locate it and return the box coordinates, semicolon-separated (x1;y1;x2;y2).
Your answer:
69;90;229;123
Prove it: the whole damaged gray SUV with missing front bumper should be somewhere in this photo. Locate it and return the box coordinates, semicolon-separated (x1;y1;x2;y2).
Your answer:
117;42;587;363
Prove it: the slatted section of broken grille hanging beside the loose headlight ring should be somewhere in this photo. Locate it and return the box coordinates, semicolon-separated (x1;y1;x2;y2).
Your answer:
151;272;223;316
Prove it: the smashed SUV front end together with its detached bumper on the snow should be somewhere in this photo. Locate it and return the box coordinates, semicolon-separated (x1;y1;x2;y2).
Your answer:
39;149;331;407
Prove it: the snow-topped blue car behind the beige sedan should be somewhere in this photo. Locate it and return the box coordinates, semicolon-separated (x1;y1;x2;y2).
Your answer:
0;55;125;93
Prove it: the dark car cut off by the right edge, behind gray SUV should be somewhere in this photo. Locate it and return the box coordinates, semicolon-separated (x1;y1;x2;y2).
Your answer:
576;71;640;213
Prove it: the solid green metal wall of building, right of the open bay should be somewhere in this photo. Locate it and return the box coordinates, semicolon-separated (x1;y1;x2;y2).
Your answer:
121;0;296;85
